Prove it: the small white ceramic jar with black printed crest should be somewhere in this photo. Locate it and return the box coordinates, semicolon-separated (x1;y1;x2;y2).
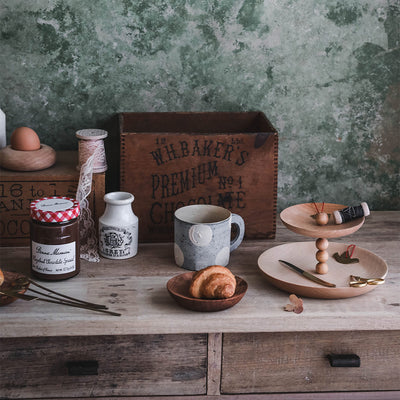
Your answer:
99;192;139;260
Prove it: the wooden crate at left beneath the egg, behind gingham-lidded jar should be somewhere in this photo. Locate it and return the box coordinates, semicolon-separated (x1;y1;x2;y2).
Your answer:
0;151;105;246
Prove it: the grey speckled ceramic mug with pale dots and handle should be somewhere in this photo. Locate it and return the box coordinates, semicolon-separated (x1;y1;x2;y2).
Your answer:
174;204;244;271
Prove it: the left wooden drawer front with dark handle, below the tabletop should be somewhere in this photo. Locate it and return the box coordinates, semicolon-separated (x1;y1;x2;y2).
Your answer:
0;334;207;399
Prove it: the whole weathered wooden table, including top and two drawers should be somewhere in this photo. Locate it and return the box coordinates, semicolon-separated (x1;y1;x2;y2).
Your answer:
0;212;400;399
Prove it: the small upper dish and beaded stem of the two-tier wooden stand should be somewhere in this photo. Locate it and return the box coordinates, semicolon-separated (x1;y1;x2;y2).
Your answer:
280;203;365;274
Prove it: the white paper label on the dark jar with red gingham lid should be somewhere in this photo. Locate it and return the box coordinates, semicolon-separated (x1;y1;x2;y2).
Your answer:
32;241;76;275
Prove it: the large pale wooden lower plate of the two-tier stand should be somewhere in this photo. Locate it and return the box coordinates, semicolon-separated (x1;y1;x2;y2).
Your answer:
258;242;388;299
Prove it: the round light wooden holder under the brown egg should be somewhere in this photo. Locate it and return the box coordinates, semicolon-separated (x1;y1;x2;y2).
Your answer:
0;144;56;172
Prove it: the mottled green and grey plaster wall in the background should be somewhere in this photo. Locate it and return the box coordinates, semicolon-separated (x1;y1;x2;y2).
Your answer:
0;0;400;210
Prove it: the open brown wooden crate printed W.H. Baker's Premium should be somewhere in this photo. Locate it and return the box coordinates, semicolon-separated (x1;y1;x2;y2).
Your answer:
119;112;278;242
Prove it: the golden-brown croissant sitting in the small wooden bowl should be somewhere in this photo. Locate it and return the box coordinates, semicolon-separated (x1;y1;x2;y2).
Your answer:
189;265;236;299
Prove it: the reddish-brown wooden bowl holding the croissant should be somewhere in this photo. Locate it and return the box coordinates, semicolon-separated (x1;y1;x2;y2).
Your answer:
167;272;247;312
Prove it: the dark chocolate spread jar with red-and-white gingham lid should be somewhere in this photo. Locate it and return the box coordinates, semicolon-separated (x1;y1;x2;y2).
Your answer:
30;196;80;281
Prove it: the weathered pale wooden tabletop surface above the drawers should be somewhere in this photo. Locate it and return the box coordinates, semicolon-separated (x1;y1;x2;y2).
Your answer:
0;211;400;337
